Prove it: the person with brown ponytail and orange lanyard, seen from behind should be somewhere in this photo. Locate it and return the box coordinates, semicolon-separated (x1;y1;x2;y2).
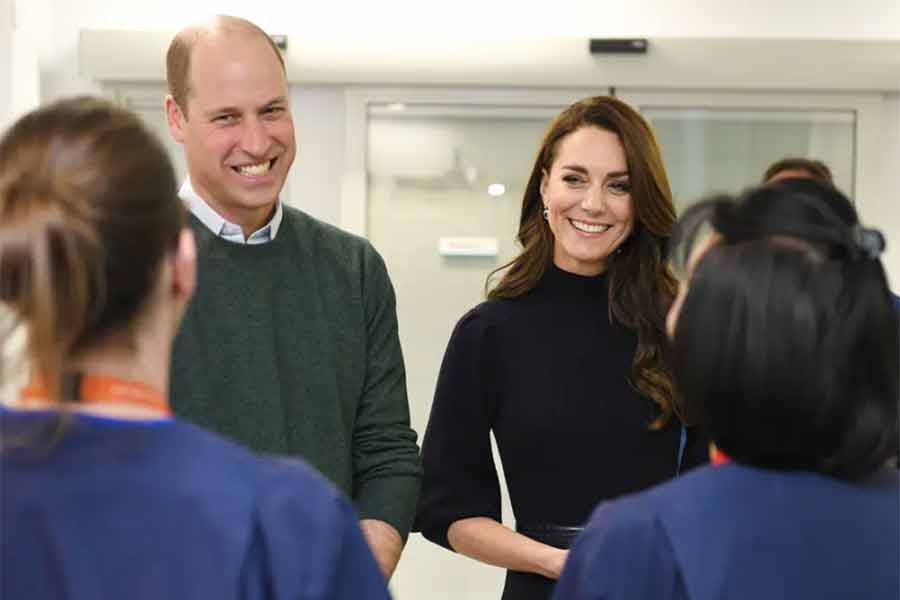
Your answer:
0;97;388;600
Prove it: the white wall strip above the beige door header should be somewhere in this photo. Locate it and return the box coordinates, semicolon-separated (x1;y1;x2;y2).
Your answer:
42;0;900;97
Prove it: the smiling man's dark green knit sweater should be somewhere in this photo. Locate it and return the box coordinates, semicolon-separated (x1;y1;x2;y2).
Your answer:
171;206;421;539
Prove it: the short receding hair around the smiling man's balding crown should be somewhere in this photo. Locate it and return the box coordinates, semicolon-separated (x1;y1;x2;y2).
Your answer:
166;15;287;117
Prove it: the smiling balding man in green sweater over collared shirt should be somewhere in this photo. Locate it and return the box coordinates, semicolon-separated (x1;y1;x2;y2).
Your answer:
165;17;421;577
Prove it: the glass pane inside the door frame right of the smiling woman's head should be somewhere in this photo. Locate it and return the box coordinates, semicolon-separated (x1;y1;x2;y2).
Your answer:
641;107;856;211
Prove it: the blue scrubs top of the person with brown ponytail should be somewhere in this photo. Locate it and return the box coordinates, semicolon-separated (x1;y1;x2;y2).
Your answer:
0;410;389;600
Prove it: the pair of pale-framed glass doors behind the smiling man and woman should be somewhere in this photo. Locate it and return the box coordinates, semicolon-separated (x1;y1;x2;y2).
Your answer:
356;88;877;600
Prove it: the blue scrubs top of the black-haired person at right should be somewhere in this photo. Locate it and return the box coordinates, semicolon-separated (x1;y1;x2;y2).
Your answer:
553;463;900;600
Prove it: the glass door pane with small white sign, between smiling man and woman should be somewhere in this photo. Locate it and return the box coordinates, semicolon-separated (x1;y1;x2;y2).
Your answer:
367;105;559;600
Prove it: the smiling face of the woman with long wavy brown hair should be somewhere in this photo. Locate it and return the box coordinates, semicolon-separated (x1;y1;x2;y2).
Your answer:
541;126;634;275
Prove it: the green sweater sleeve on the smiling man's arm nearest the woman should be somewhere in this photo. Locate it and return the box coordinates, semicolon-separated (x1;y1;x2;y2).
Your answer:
353;244;421;540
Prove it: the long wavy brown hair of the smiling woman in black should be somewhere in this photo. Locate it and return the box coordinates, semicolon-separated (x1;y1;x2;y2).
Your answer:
486;96;677;429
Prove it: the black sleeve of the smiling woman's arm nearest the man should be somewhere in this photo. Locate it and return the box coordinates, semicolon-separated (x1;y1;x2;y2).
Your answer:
415;308;501;550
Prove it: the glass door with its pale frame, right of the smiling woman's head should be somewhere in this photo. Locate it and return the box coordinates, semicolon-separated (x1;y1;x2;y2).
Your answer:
618;89;880;209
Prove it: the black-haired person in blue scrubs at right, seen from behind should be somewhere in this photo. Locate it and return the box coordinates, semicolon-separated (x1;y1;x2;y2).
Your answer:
554;179;900;600
